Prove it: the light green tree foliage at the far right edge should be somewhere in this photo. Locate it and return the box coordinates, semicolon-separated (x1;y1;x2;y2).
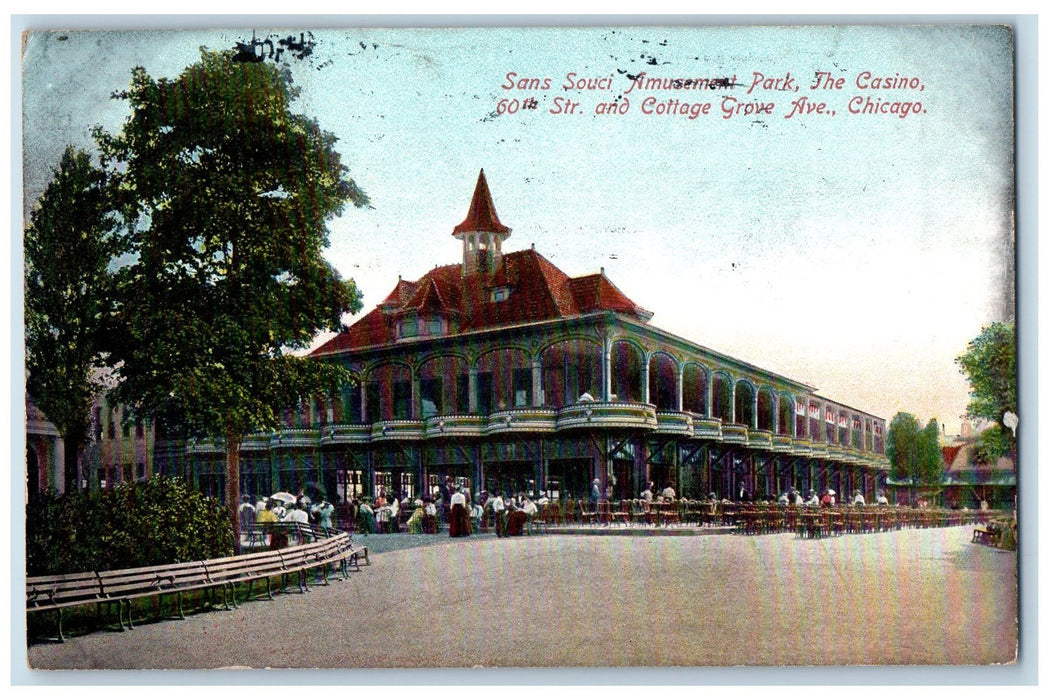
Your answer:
955;322;1016;424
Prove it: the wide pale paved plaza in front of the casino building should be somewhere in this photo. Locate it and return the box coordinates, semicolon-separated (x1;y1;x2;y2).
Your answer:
28;527;1016;669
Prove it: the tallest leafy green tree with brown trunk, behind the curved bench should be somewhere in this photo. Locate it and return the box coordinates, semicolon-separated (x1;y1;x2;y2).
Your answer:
95;49;367;542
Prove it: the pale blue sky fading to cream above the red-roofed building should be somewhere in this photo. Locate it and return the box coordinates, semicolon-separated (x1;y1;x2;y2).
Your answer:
22;25;1014;433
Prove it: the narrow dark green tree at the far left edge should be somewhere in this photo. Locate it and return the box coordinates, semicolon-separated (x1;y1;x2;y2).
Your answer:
24;147;122;490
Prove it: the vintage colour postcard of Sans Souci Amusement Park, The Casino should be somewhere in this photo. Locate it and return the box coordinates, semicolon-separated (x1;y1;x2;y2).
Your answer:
16;23;1030;671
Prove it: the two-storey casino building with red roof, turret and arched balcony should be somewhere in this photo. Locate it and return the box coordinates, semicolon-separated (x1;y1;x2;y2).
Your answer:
176;171;887;501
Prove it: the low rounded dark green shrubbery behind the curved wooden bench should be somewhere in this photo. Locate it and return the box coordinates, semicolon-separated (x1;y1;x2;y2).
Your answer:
25;476;233;576
